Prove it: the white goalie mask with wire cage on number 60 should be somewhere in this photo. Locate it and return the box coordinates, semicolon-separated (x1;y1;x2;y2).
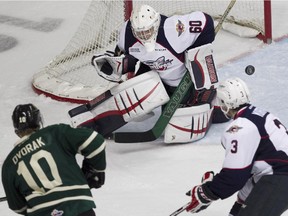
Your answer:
130;5;160;52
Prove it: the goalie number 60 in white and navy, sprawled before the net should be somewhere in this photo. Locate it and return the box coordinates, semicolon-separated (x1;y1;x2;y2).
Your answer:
69;5;226;143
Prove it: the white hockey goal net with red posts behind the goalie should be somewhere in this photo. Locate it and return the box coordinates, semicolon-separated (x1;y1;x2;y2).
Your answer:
32;0;272;103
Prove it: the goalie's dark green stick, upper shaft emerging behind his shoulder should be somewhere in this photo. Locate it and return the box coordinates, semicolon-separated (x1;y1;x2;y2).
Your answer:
113;0;236;143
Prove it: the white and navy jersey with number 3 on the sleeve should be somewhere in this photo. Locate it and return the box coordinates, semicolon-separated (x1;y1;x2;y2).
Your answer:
207;105;288;200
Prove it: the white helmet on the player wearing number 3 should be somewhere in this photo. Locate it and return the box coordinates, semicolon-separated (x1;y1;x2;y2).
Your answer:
217;78;250;114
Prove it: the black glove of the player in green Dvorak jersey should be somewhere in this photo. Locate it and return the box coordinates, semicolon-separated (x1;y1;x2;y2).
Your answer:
82;159;105;188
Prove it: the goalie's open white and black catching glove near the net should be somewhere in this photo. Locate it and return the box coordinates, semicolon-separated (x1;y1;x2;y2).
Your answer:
92;51;137;82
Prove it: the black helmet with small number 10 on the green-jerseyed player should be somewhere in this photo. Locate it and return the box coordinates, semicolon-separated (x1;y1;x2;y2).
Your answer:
12;104;42;137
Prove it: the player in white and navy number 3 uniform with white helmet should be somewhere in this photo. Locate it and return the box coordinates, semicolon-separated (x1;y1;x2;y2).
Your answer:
186;78;288;216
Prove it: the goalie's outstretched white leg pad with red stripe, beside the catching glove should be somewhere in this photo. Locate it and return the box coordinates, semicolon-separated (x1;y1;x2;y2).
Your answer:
73;71;169;134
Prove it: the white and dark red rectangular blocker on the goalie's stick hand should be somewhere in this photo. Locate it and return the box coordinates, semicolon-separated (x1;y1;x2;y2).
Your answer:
185;43;218;90
